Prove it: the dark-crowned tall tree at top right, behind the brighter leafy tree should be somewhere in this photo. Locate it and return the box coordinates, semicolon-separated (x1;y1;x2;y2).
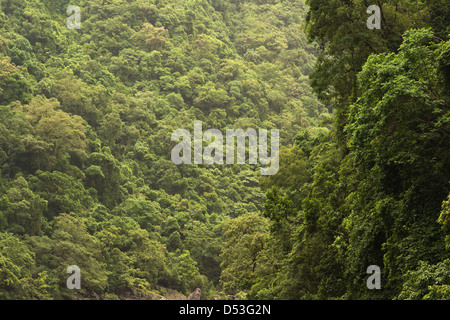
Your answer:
306;0;428;147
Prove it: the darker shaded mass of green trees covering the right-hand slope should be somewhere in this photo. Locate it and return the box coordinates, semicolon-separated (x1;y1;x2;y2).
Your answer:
246;0;450;299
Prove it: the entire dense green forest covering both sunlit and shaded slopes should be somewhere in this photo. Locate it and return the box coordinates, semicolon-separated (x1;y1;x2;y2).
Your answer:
0;0;450;299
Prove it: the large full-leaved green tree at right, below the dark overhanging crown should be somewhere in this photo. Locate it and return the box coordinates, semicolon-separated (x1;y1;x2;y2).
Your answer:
347;29;450;296
